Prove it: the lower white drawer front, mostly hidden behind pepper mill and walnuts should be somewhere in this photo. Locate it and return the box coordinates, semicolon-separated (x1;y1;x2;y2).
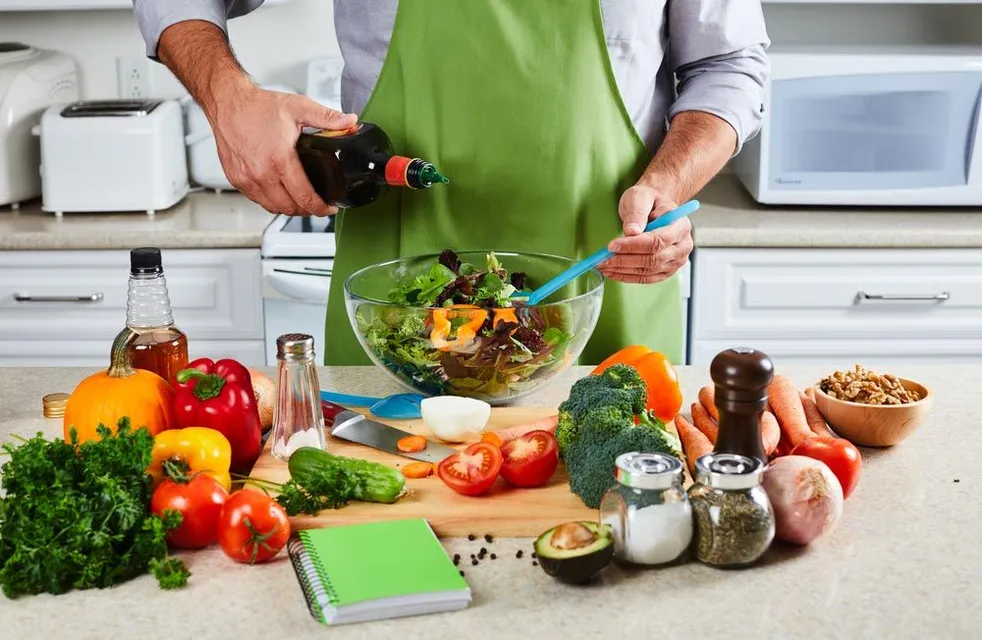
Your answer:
689;339;982;368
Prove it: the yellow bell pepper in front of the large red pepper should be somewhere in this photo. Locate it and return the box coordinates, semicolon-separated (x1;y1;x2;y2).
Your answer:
148;427;232;489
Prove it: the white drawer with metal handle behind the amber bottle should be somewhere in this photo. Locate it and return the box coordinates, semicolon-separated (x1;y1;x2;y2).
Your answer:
0;249;263;342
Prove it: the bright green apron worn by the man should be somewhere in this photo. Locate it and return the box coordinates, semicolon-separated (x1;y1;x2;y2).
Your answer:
325;0;683;365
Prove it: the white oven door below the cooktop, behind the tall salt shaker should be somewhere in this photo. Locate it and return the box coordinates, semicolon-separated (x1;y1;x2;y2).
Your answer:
262;259;334;366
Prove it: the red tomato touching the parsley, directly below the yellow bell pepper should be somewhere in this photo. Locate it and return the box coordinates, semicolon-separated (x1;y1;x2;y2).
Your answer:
150;473;228;549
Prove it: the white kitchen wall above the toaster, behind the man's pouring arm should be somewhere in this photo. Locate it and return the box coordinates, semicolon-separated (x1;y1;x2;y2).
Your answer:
0;0;340;99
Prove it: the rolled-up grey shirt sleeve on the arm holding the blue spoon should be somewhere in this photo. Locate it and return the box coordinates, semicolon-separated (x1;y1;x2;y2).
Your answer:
668;0;771;154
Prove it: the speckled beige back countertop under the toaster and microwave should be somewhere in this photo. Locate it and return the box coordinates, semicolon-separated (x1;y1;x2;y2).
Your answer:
0;175;982;251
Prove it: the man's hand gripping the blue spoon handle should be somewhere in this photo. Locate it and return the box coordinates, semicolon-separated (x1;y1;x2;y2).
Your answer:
599;184;692;284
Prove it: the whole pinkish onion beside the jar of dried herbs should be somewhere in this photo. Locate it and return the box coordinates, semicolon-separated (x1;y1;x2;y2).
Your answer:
763;456;843;544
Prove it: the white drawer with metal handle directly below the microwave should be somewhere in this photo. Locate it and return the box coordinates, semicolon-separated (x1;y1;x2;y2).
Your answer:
692;248;982;340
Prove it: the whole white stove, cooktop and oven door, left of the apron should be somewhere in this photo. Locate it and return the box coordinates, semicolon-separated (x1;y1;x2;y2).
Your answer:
262;215;336;366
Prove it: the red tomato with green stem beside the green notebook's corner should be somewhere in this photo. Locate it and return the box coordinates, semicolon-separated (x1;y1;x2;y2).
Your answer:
218;489;290;564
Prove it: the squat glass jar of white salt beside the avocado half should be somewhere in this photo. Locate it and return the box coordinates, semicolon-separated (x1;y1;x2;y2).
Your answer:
600;453;692;566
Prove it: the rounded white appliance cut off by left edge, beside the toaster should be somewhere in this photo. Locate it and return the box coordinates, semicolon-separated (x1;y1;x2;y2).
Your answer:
0;42;78;209
